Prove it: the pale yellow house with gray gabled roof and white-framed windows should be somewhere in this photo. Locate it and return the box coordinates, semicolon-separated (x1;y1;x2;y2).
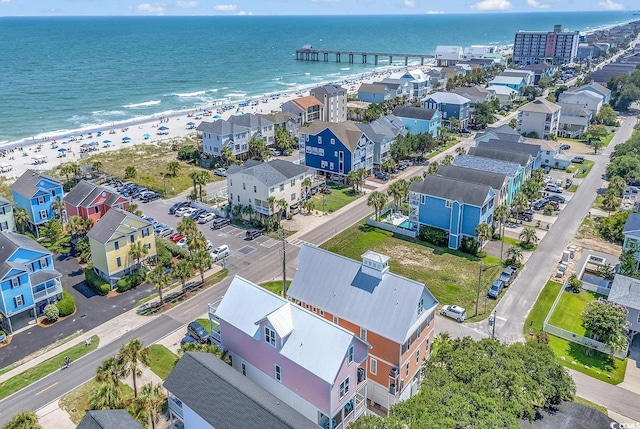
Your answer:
87;208;156;285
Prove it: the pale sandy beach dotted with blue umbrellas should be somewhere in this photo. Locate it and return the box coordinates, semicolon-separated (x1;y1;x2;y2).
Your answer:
0;66;413;181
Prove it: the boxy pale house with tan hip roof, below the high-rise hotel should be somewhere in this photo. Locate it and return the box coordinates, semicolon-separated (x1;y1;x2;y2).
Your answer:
516;97;560;139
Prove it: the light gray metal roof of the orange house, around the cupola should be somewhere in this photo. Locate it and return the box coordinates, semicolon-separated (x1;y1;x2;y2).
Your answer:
288;245;438;344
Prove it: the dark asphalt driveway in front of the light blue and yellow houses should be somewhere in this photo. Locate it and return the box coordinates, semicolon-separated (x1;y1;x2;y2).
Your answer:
0;255;155;368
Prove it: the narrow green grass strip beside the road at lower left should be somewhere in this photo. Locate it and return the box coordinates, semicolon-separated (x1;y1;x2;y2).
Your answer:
0;335;100;399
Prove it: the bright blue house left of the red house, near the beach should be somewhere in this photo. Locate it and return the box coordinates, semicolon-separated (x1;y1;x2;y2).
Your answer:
11;170;64;234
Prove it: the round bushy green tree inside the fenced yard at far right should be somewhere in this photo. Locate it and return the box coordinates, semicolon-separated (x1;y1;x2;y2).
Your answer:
580;298;629;354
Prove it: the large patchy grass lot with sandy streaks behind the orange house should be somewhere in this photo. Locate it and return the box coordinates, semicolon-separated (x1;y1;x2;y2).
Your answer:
321;222;502;321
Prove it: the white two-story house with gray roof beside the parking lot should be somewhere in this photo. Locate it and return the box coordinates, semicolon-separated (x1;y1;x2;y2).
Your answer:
227;159;313;217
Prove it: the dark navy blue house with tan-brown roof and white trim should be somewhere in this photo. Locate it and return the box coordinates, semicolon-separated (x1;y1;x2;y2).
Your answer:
298;121;374;176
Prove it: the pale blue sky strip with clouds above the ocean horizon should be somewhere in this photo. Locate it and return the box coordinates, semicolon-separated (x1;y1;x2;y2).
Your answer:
0;0;640;16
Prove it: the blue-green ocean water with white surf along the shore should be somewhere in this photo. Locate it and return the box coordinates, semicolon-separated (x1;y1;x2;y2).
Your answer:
0;11;637;142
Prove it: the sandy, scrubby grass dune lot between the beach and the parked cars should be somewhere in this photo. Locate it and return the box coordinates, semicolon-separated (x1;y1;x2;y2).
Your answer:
74;143;223;197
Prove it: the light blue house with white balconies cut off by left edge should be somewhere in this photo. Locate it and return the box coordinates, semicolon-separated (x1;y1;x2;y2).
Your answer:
0;231;62;332
